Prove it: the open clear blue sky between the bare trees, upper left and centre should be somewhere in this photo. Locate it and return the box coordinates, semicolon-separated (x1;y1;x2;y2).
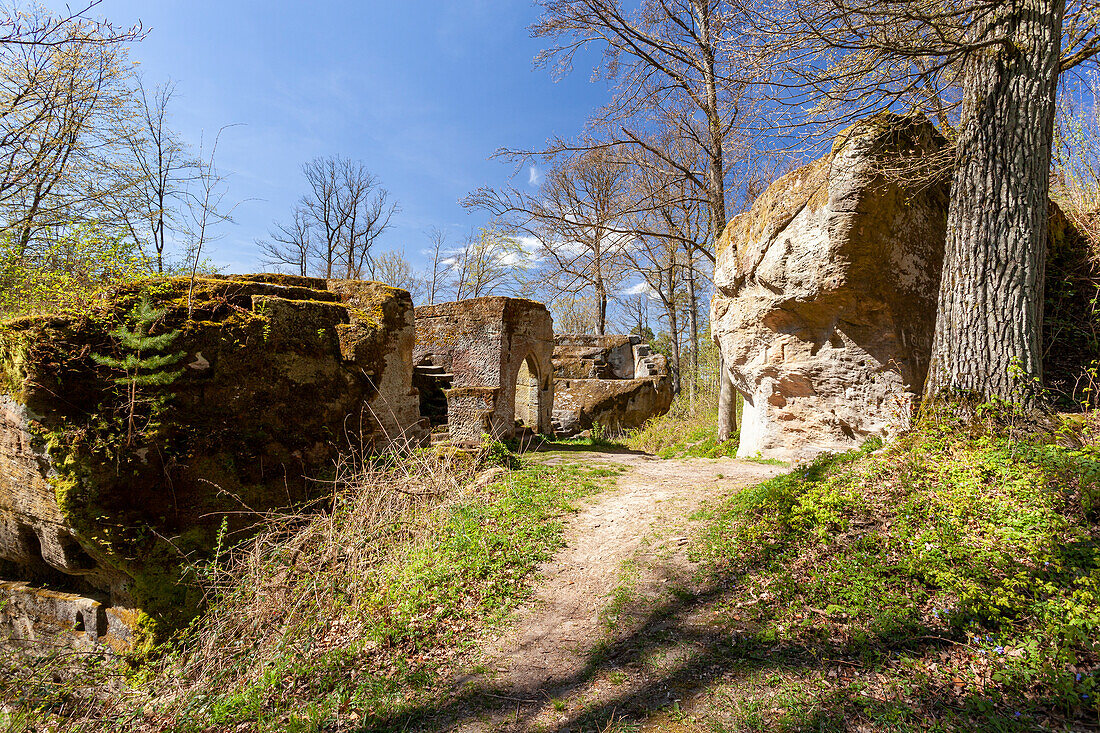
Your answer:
46;0;606;272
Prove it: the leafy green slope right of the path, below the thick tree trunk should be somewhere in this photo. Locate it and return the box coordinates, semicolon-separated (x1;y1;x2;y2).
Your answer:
696;416;1100;731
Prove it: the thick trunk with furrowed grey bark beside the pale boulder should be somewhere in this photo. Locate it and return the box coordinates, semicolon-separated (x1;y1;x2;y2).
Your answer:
925;0;1065;403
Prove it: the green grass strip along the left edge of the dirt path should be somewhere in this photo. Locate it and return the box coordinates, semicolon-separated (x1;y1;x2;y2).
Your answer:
169;464;600;731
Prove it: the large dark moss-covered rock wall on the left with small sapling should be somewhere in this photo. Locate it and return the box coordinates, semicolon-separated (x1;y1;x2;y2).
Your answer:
0;275;427;645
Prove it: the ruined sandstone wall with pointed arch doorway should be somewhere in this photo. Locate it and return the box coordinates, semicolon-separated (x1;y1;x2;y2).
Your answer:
413;297;554;445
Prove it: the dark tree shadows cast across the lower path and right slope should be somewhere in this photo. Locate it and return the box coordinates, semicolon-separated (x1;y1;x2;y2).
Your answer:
362;563;1060;733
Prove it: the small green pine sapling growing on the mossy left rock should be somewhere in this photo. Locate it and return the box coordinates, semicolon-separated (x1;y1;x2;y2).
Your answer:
91;294;185;448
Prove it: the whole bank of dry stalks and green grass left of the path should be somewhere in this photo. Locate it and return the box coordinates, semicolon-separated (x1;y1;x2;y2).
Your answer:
0;453;620;733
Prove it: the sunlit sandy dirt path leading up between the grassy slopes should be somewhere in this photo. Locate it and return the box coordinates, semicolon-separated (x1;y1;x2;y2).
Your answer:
452;452;782;732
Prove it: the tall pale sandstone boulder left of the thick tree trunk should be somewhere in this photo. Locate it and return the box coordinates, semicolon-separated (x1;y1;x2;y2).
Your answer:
711;114;947;460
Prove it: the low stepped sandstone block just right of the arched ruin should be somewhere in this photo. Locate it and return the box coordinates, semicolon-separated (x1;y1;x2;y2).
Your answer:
553;336;672;437
